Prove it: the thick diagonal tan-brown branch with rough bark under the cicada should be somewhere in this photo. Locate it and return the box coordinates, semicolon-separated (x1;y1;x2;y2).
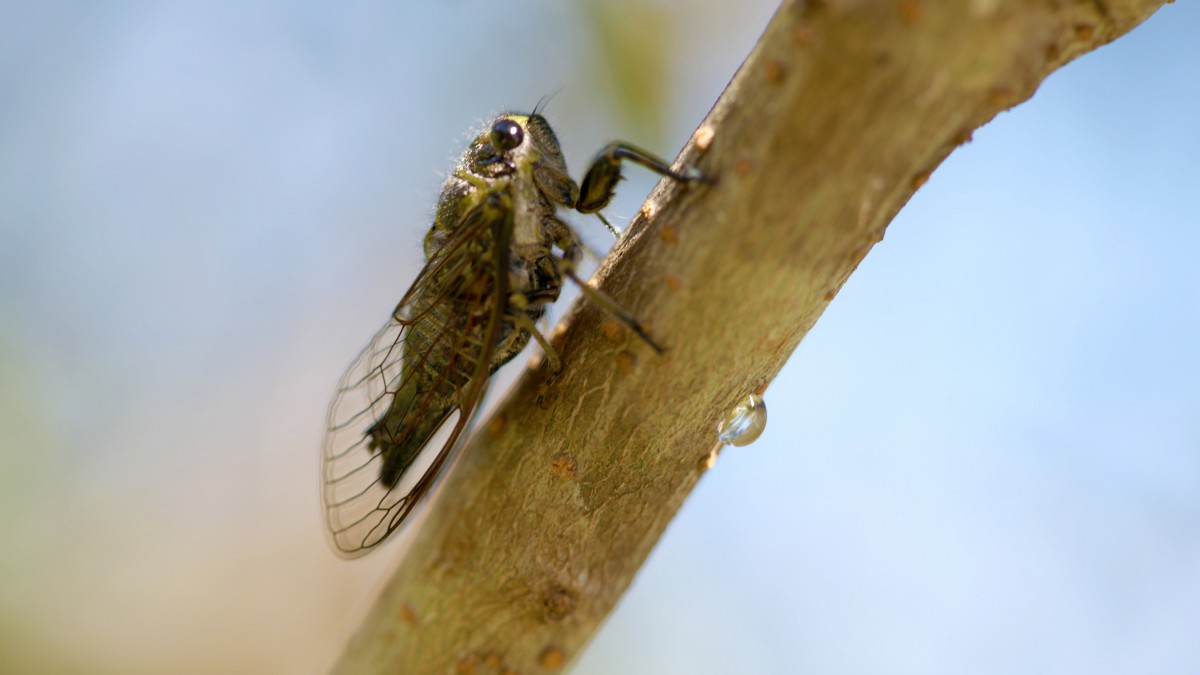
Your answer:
334;0;1163;673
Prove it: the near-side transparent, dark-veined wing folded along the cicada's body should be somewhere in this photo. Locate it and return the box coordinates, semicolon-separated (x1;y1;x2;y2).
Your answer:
322;189;511;557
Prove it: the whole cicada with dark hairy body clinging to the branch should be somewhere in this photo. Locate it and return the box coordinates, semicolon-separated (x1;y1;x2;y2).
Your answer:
322;109;703;557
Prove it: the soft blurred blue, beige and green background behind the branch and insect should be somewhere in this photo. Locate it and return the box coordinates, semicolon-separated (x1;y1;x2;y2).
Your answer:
0;0;1200;675
